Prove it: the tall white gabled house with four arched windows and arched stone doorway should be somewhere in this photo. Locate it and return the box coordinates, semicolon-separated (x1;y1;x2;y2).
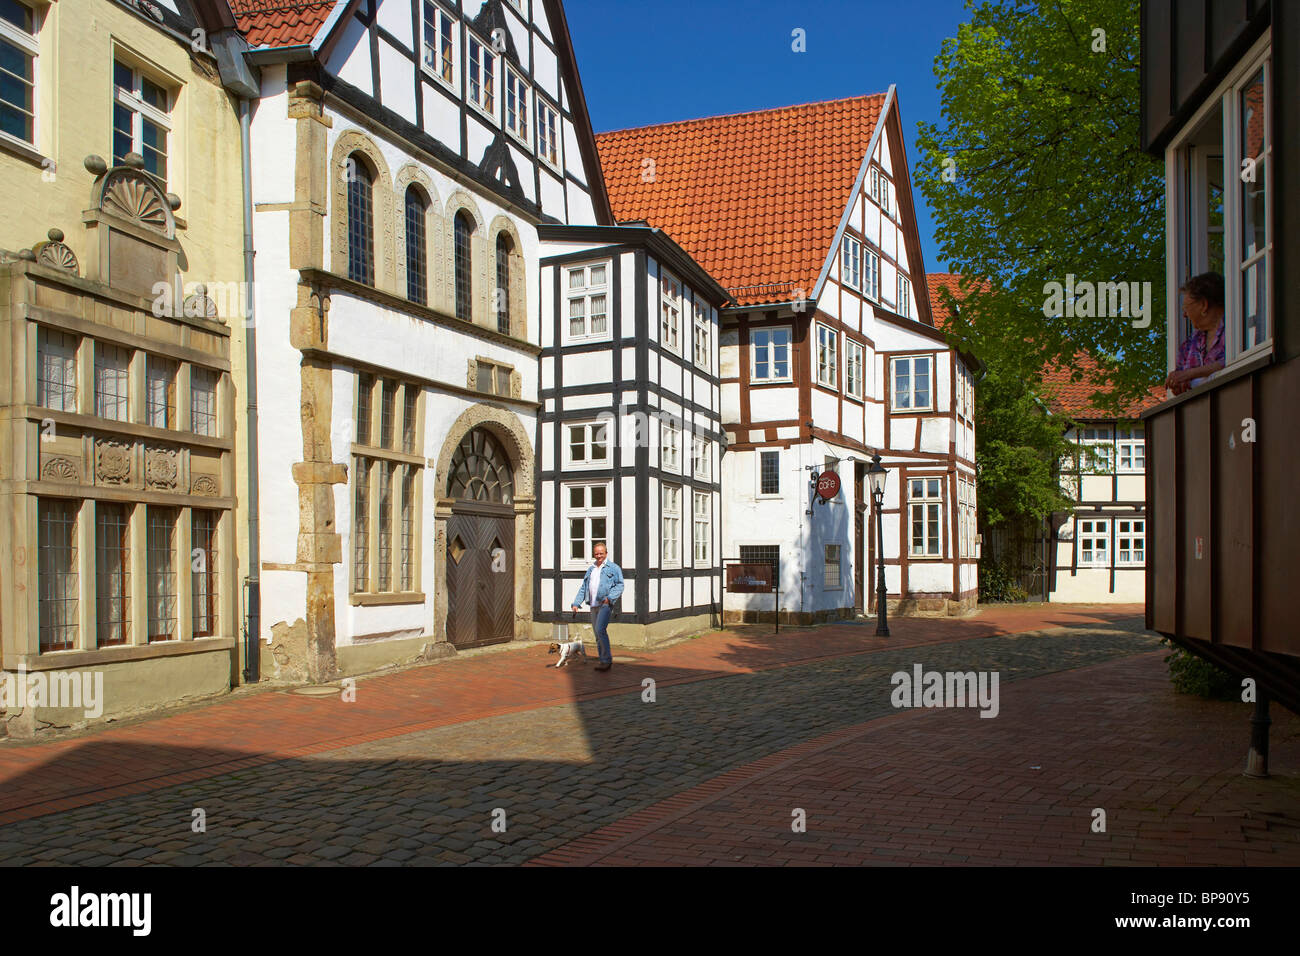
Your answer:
233;0;612;678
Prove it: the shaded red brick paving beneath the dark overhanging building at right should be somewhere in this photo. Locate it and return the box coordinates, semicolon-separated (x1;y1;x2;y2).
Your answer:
532;652;1300;866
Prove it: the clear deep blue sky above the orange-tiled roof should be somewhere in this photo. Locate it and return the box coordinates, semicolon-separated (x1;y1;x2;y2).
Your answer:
564;0;967;272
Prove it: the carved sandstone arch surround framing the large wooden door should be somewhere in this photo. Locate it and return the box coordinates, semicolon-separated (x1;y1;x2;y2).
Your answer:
426;405;536;641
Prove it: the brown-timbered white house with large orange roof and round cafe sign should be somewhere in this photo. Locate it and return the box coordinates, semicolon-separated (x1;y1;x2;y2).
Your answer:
597;88;976;629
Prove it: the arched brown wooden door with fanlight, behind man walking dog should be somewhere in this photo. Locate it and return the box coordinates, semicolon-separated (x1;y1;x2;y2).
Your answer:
447;428;515;648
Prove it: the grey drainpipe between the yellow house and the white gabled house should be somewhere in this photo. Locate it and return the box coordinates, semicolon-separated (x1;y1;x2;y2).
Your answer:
211;30;261;683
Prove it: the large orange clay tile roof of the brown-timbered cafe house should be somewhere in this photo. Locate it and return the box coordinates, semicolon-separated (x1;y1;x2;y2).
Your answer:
595;94;885;304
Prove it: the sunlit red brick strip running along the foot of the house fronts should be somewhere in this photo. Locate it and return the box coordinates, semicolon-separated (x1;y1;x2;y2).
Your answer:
0;605;1141;826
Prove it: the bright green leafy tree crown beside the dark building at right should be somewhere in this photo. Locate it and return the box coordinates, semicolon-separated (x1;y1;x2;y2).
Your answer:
915;0;1166;411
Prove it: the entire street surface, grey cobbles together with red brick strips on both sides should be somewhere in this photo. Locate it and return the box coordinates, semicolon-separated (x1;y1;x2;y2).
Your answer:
0;607;1300;865
